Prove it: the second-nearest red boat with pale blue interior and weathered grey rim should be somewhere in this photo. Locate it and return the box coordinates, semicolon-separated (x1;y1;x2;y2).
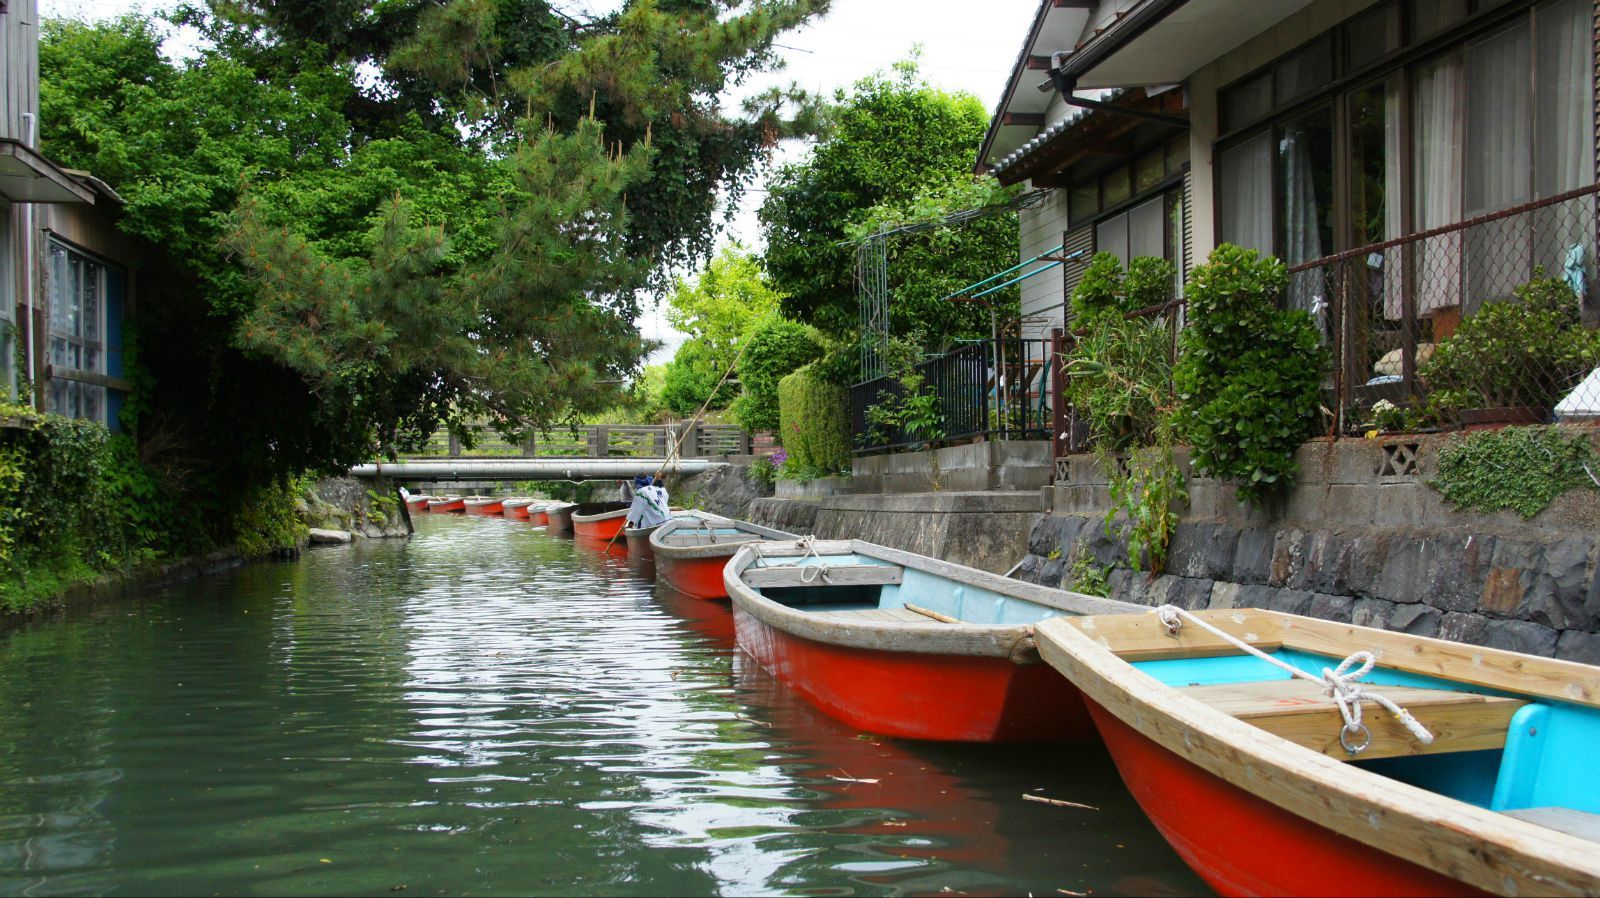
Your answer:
723;539;1138;743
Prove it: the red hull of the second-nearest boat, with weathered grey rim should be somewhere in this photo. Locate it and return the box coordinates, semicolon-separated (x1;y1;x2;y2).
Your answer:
733;603;1094;743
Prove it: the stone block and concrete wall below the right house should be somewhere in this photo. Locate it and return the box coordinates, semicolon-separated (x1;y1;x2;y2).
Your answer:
1018;437;1600;664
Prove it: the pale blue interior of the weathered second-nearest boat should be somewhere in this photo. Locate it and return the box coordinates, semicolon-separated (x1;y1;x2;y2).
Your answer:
757;554;1062;626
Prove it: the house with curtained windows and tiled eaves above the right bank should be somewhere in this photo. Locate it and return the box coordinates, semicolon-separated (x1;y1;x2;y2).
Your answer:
978;0;1600;432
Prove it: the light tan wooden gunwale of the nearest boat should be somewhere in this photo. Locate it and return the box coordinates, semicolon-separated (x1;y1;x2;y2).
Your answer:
1035;608;1600;895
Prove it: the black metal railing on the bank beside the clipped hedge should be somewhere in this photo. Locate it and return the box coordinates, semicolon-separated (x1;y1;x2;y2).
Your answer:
850;338;1054;455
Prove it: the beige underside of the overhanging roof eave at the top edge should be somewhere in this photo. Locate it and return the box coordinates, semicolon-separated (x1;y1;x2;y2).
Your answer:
1062;0;1312;88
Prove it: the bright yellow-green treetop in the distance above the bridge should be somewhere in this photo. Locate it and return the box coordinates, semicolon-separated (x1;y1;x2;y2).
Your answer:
667;245;779;376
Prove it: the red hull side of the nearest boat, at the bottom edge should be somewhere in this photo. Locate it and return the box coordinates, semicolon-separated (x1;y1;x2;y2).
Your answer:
1086;700;1483;895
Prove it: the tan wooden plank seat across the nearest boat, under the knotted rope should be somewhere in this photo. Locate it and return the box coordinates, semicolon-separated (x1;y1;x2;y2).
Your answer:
1182;679;1526;760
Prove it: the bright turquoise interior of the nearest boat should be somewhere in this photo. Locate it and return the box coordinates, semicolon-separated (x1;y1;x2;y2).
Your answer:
1134;648;1600;813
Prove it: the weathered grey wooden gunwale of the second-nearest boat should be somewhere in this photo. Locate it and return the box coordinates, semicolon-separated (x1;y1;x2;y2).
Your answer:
722;539;1138;664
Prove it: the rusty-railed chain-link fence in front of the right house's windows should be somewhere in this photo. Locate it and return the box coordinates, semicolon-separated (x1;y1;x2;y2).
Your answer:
1285;186;1600;434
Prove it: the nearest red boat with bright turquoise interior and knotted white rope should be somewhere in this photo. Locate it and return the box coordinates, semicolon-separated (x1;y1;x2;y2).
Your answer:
1038;608;1600;895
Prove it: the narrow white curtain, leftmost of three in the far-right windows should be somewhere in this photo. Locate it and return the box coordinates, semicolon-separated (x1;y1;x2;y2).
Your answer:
1411;54;1464;317
